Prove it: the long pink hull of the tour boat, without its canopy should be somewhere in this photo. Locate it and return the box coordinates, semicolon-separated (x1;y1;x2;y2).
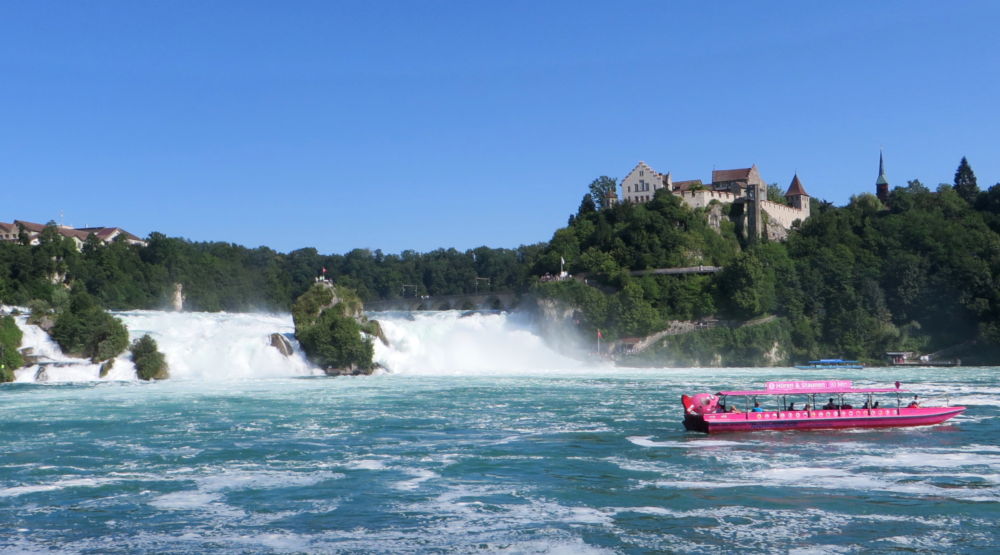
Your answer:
684;407;965;434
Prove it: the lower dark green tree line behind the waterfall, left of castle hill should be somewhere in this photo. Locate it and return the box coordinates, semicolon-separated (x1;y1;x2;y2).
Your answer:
0;230;543;311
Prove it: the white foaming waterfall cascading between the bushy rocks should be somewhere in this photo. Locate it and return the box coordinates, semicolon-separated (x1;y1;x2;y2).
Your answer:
7;311;583;383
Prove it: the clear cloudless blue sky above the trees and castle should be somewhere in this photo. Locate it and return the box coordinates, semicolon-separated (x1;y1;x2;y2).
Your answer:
0;0;1000;253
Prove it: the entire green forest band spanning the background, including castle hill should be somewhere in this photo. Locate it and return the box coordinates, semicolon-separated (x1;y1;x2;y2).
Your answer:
0;159;1000;364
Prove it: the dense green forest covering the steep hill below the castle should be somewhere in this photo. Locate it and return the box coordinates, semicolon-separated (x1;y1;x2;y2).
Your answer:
541;163;1000;365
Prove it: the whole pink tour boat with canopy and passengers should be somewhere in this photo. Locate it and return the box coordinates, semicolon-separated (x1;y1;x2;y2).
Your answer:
681;380;965;434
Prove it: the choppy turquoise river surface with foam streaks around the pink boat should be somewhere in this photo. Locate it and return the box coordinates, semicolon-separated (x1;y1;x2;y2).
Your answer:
0;368;1000;553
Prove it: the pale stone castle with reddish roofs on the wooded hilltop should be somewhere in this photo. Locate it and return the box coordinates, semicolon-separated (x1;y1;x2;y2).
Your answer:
616;161;809;239
